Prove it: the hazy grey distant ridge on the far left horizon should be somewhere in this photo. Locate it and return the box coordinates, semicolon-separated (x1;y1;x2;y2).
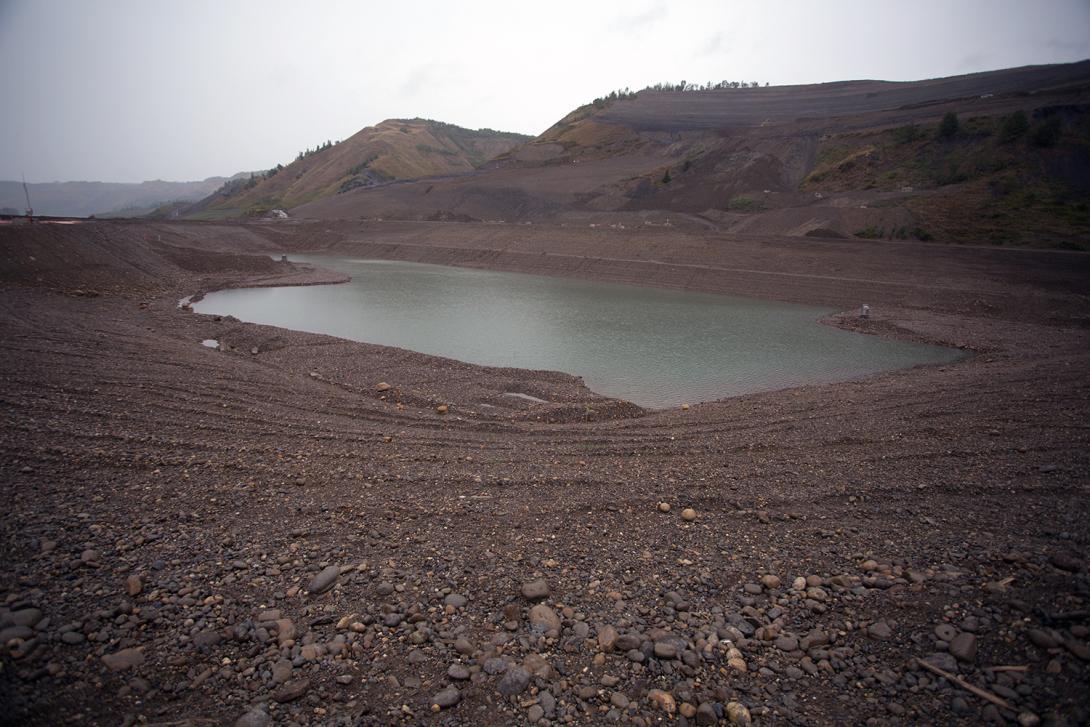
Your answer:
0;177;245;217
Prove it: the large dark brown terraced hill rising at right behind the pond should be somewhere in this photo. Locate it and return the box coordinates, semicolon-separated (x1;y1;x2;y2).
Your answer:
293;61;1090;246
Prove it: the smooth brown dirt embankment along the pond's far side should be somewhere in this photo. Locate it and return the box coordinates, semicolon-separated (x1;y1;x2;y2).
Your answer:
268;221;1090;329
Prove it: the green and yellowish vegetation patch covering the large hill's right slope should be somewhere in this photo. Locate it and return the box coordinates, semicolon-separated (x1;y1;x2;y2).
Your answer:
801;105;1090;249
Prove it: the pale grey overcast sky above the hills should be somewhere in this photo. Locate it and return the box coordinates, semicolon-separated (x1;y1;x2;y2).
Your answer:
6;0;1090;182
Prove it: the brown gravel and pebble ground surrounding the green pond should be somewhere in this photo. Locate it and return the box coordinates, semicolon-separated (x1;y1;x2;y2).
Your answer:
0;222;1090;725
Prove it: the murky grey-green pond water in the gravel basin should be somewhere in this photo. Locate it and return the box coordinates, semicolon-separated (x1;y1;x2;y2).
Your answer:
193;255;960;408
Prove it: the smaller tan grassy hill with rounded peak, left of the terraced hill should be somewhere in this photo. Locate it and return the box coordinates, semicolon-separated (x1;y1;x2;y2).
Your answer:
180;119;530;218
